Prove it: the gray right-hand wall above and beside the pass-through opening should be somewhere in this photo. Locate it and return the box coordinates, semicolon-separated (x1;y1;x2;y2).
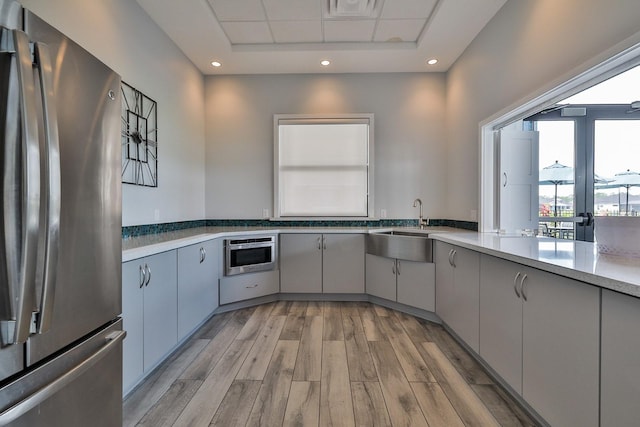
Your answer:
446;0;640;220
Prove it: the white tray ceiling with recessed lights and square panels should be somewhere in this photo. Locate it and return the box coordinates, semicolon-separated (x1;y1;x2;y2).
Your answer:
137;0;506;74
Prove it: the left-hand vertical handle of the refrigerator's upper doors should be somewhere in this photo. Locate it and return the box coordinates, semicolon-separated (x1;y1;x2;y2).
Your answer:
1;30;40;344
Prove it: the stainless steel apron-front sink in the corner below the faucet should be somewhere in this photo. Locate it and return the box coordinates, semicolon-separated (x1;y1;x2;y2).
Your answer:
367;231;433;262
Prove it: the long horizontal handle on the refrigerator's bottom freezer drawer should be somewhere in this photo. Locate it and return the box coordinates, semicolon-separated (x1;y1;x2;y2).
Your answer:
0;331;127;426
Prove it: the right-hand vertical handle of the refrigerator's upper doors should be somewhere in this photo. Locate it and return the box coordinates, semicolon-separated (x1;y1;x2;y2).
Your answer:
34;43;61;333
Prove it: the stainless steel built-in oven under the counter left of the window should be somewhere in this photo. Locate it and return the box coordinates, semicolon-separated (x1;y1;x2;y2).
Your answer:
224;235;278;276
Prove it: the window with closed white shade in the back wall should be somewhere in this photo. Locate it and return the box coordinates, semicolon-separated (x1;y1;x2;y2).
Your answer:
274;114;374;218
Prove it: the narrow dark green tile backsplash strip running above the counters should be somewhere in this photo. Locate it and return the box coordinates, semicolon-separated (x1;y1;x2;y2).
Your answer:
122;219;478;239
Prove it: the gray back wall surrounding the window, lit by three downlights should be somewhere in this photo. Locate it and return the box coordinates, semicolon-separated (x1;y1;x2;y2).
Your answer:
205;74;446;218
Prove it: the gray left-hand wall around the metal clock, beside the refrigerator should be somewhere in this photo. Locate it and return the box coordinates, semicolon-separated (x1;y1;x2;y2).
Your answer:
21;0;204;225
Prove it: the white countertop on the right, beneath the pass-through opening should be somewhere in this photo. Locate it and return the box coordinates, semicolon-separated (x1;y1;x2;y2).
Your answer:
431;232;640;297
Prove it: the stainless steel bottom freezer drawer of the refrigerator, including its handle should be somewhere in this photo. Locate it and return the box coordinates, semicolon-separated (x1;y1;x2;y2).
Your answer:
0;320;125;427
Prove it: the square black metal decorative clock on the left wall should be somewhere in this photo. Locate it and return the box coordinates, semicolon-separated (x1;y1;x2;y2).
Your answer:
121;82;158;187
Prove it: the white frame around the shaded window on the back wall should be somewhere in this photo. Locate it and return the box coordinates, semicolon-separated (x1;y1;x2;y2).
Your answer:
273;113;375;220
